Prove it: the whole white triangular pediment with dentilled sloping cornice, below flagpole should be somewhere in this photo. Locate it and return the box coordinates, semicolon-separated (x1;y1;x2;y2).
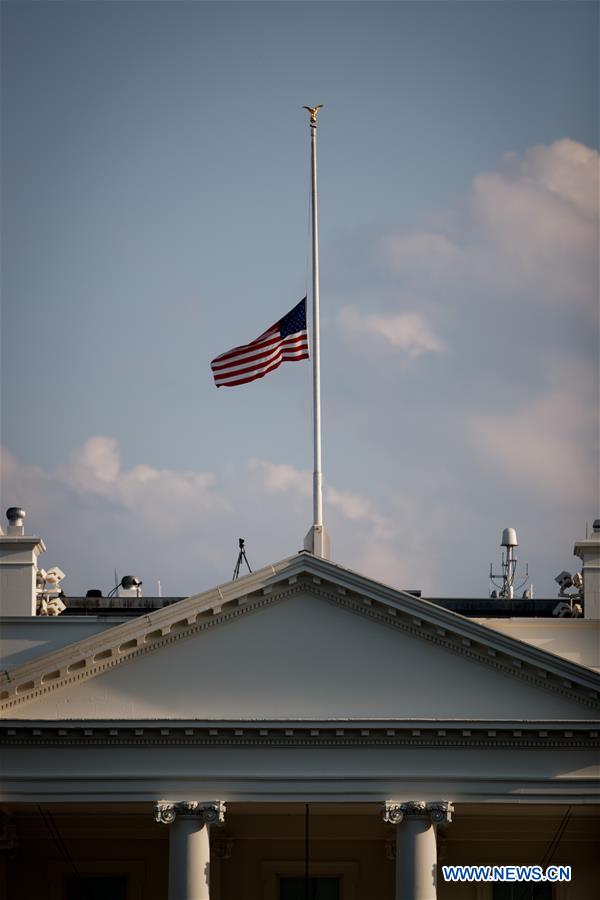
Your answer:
2;554;599;720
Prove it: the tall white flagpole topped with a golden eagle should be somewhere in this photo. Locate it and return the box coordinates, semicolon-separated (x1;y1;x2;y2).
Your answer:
304;105;329;559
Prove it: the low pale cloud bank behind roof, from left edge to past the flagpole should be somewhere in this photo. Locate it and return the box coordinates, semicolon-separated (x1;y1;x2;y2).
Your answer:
2;435;436;595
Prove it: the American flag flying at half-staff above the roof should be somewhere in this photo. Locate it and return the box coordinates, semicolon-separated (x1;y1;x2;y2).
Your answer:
210;297;308;387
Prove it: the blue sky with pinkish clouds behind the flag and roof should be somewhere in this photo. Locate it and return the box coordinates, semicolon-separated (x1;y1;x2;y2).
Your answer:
1;0;600;597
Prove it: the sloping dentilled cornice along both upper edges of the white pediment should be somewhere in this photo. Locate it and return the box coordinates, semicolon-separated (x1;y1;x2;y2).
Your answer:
0;553;600;715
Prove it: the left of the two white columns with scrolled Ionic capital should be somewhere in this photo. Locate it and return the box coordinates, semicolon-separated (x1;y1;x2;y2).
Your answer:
154;800;225;900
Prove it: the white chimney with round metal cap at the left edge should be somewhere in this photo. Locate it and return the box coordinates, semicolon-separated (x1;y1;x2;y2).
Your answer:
0;506;46;616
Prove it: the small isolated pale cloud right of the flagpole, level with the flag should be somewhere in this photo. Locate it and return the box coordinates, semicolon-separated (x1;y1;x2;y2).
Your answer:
339;306;446;358
